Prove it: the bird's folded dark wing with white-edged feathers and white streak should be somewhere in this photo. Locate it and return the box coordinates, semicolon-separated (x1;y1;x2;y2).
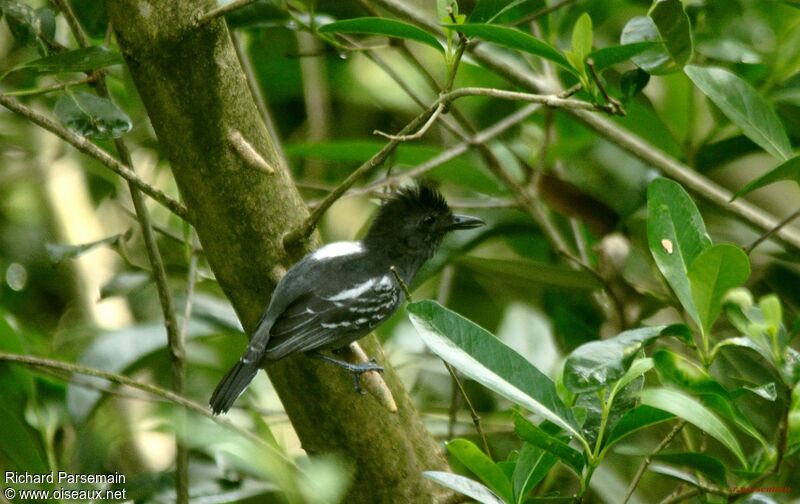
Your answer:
266;279;400;360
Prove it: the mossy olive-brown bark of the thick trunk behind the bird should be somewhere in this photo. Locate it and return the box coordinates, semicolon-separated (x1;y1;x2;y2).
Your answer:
107;0;446;503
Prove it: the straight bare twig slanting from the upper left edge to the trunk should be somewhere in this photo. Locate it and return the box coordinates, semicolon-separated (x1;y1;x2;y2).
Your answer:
0;94;191;222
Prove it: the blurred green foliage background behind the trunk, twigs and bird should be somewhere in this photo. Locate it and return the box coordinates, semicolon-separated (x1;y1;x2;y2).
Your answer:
0;0;800;502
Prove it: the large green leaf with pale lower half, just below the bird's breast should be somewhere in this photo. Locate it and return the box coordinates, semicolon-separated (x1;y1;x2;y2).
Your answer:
408;300;580;438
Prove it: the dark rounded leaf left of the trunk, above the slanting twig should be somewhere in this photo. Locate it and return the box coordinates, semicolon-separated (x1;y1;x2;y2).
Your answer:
55;91;133;138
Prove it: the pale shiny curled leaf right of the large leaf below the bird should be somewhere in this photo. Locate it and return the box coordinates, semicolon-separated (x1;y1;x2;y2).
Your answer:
564;324;689;393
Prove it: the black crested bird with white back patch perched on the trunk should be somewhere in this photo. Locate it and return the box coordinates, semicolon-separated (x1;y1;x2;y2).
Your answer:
209;182;485;415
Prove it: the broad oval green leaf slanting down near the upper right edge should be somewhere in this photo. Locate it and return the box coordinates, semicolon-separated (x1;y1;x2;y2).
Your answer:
684;65;793;161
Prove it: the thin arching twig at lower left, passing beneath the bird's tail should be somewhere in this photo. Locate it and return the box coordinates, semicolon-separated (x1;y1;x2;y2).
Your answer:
0;352;302;472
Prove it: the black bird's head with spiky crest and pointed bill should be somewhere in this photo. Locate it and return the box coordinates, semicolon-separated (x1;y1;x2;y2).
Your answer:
364;183;484;259
